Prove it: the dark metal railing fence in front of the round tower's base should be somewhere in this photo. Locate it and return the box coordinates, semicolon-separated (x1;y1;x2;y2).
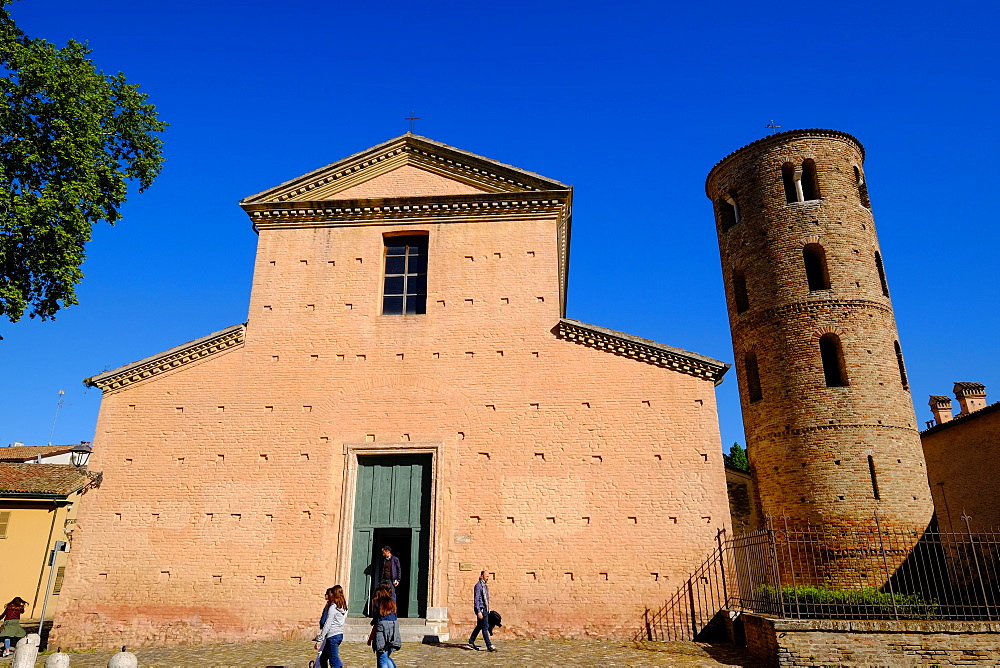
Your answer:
635;517;1000;640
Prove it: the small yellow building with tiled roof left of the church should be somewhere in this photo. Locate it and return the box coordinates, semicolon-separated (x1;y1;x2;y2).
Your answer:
0;464;101;619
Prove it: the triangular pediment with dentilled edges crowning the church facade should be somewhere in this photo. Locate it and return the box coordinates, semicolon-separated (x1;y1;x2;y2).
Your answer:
242;134;570;205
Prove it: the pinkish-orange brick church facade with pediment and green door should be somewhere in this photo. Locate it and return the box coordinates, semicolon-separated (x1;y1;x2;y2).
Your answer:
52;134;729;647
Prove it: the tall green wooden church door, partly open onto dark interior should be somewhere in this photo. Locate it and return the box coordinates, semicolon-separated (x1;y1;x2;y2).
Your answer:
348;455;431;617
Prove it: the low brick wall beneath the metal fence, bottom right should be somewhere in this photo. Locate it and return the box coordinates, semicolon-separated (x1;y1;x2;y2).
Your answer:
740;613;1000;667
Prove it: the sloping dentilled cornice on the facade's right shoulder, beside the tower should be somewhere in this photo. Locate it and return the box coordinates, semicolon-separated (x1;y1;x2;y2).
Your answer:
553;318;730;385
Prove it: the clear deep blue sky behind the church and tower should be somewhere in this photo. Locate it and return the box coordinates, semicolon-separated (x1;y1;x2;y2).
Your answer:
0;0;1000;448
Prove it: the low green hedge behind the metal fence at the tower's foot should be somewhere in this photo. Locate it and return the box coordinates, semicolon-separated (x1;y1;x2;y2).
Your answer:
756;585;939;619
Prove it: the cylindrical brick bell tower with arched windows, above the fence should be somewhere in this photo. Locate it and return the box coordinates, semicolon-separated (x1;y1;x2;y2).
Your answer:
706;130;933;530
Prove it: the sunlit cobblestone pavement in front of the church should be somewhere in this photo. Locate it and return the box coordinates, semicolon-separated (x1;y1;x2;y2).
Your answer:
0;640;763;668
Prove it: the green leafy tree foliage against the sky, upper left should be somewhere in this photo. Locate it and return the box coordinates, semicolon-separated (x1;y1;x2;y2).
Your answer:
0;0;166;322
